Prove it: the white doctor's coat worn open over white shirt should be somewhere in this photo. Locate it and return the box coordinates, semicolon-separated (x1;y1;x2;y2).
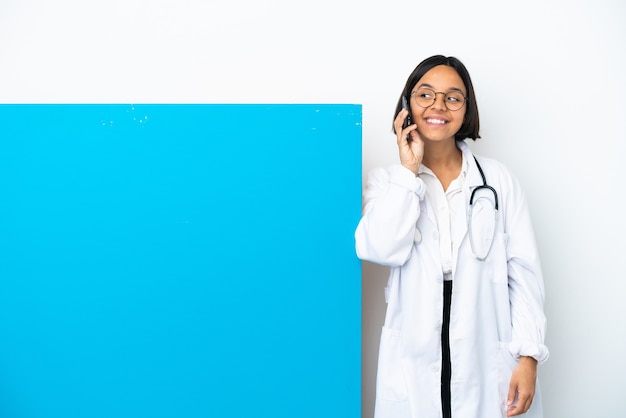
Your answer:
355;142;548;418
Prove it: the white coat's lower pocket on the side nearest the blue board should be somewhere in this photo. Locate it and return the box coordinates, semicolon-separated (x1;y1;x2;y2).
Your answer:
376;327;408;402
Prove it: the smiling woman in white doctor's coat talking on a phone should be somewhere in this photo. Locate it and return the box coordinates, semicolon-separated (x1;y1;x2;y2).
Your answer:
355;56;548;418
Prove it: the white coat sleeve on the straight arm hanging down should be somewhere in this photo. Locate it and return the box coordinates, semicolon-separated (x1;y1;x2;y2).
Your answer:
503;170;549;363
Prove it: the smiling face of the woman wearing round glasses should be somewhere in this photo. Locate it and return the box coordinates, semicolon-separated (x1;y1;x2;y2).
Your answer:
411;65;467;142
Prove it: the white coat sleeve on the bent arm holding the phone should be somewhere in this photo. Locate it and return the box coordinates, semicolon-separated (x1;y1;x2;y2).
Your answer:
355;165;425;267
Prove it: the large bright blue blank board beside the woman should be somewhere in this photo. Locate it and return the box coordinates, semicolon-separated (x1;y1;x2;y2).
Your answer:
0;105;361;418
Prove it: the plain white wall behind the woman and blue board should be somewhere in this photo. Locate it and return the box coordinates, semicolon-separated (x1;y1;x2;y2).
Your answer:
0;0;626;418
